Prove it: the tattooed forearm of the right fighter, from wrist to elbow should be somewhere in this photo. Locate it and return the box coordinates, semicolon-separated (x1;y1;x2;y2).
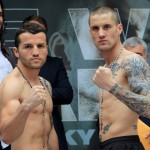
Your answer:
109;83;150;118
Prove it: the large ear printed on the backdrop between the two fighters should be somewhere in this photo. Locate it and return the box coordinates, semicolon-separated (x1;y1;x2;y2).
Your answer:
49;32;71;70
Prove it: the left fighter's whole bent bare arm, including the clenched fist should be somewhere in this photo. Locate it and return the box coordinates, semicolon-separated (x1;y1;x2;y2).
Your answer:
0;78;46;144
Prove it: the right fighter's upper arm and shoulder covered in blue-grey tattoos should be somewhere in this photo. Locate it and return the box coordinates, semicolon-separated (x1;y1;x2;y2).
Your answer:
123;55;150;95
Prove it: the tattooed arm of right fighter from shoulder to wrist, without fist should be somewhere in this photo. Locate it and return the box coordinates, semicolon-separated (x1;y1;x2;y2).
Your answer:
109;55;150;117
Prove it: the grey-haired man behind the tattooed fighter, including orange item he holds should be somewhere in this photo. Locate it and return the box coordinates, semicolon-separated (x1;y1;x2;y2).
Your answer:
123;37;150;150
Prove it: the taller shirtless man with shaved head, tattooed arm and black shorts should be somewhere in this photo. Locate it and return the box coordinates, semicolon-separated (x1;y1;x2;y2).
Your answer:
89;7;150;150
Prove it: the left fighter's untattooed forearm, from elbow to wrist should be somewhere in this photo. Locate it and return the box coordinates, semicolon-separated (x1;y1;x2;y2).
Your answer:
1;103;30;144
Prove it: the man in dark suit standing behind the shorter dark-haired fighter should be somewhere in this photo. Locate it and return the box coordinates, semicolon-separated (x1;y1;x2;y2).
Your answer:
23;15;73;150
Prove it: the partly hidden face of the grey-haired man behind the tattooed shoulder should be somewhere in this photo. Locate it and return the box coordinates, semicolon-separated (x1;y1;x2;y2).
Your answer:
125;45;146;59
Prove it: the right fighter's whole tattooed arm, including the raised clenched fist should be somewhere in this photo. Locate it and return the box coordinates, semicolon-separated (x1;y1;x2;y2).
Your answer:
93;54;150;118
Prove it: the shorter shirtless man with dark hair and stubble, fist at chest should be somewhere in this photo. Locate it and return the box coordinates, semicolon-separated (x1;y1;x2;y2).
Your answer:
0;23;58;150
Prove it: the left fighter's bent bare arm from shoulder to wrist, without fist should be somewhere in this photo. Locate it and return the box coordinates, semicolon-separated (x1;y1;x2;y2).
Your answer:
0;80;30;143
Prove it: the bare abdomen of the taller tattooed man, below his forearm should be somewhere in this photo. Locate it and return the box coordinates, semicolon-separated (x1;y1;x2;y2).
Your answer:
99;92;138;141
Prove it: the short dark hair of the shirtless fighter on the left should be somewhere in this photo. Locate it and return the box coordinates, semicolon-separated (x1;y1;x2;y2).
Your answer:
15;22;48;48
